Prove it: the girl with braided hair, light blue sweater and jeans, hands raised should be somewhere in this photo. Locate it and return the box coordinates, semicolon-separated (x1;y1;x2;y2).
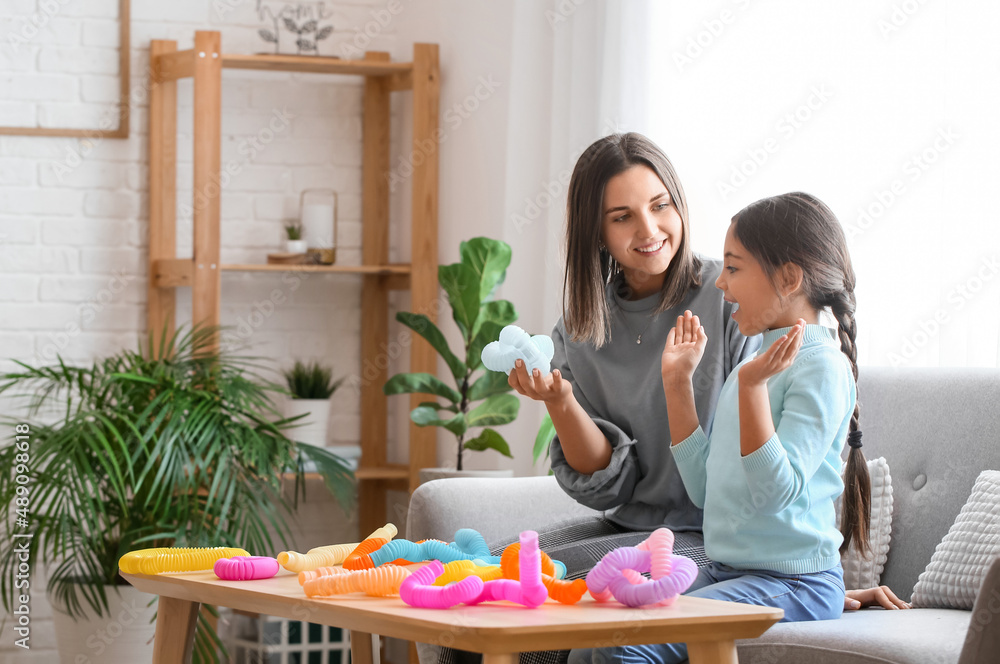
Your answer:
570;193;870;663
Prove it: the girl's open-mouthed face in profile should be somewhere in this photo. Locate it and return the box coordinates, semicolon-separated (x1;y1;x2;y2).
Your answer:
715;224;800;337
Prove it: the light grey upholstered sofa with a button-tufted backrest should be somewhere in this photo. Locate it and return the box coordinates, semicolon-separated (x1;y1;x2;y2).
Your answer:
407;367;1000;664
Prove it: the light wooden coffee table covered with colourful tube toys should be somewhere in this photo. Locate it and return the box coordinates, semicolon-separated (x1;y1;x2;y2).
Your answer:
122;570;783;664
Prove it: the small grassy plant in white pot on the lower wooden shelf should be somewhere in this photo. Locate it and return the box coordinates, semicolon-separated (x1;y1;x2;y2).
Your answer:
283;360;344;447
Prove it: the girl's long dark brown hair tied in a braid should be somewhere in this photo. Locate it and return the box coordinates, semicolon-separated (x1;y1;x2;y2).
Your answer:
733;192;871;553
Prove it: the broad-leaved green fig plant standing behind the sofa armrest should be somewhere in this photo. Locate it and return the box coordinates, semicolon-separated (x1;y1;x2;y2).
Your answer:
383;237;520;481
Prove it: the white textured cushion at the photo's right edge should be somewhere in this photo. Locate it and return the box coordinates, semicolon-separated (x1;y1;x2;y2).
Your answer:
913;470;1000;611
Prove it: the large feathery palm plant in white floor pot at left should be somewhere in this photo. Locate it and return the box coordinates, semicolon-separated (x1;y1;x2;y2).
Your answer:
0;328;352;662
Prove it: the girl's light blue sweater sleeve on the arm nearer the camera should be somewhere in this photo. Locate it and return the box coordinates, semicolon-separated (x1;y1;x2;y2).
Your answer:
742;347;857;514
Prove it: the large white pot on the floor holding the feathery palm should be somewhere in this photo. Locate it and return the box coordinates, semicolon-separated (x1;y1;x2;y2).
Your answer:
52;586;156;664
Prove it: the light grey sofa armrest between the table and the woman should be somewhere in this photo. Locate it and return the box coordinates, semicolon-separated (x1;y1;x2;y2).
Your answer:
406;476;601;542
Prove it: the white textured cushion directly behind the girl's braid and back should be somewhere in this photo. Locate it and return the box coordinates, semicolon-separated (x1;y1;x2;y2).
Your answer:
837;457;892;590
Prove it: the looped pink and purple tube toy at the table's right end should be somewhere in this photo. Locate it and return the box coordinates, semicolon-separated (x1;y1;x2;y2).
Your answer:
587;528;698;607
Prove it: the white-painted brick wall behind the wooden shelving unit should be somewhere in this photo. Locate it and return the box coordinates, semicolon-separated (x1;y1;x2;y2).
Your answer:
0;0;402;664
